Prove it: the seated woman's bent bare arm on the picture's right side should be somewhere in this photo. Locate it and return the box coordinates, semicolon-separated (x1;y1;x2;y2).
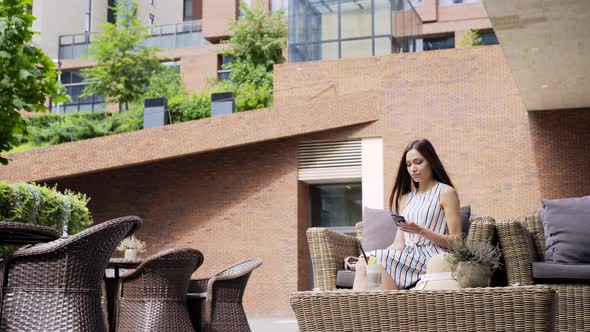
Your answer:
396;186;461;248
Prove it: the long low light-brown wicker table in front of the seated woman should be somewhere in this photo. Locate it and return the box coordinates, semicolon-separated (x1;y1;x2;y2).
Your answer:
290;286;555;332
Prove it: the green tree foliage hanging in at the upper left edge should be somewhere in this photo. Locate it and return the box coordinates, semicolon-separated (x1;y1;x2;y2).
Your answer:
0;0;66;164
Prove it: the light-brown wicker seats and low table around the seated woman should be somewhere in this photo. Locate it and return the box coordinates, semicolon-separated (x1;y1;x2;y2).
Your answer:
290;209;590;331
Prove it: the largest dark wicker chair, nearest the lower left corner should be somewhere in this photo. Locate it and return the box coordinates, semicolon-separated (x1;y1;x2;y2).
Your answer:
0;217;141;332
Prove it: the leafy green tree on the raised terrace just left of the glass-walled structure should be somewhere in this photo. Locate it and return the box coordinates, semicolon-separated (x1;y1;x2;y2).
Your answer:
220;1;287;112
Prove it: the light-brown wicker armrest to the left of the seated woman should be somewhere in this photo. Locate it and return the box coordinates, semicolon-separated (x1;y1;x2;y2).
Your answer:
307;227;360;290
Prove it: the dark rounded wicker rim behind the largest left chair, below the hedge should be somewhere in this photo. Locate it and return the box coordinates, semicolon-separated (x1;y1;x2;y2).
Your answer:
0;221;61;245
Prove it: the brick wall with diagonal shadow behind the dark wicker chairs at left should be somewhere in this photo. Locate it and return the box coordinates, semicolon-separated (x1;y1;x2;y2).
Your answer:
46;141;302;315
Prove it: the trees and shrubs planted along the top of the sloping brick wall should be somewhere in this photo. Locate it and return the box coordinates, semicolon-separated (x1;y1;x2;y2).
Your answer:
11;2;287;152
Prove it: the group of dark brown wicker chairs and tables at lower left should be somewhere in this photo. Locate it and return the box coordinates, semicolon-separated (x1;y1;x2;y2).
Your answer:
0;216;262;331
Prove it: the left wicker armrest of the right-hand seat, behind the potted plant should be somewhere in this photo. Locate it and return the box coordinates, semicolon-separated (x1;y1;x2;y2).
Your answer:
496;220;533;285
